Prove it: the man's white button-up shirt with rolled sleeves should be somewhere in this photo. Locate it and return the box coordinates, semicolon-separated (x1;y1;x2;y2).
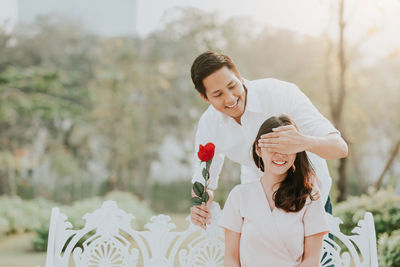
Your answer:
192;78;339;203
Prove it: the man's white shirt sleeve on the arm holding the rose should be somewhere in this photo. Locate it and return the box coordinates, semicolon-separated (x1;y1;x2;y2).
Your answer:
192;118;225;190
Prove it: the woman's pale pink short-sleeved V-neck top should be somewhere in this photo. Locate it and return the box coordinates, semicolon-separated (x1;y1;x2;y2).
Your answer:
219;181;329;267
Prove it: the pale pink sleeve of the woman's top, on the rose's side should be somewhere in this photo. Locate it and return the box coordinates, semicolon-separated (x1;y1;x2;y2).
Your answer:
218;186;243;233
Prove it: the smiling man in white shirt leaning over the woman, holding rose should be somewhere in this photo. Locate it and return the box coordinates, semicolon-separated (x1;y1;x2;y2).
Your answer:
191;52;348;228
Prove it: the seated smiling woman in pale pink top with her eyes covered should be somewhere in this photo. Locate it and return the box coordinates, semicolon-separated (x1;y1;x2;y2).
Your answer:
219;115;329;267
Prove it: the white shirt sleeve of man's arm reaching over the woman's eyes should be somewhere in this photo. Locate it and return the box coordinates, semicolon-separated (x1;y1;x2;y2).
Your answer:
288;84;340;137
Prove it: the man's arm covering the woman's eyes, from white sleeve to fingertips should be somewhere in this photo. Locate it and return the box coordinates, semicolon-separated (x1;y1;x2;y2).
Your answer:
261;84;348;159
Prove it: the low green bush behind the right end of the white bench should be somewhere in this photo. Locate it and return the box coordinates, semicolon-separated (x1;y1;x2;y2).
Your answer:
333;188;400;237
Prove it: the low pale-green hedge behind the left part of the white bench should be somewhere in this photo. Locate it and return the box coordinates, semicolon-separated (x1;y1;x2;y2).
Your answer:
0;191;152;251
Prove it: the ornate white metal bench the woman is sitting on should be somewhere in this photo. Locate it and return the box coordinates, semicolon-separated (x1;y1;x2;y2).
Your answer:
46;201;378;267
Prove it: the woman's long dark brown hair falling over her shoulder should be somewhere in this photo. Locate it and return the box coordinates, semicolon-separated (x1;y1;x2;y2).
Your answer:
253;115;316;212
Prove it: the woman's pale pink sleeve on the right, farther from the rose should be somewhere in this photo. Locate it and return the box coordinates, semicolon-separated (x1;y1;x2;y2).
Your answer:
303;196;330;236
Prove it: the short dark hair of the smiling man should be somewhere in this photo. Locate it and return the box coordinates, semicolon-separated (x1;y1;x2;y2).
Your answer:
190;51;239;98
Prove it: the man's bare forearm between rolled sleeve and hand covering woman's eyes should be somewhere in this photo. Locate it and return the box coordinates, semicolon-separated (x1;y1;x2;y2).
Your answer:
305;133;348;159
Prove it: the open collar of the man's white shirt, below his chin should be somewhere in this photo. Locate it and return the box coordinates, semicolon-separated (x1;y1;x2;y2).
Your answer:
210;79;262;123
